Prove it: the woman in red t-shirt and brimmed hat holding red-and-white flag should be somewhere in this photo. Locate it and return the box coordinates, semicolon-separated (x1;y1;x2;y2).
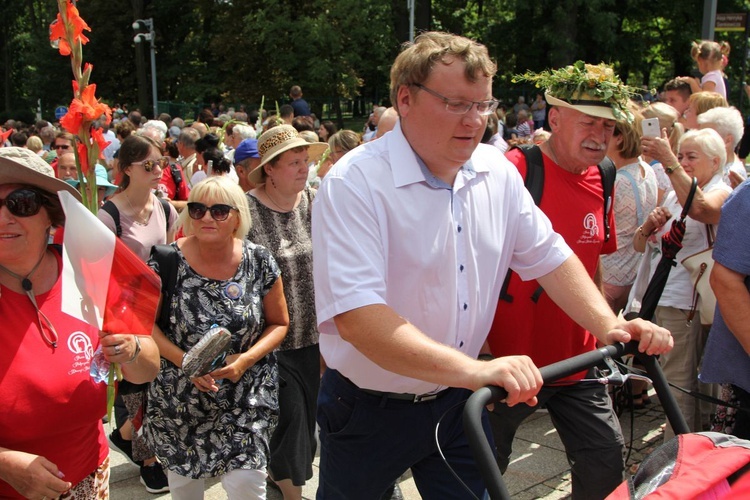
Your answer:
0;148;159;499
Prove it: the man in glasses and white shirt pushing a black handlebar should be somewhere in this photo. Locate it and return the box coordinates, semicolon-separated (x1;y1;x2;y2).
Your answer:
312;33;671;499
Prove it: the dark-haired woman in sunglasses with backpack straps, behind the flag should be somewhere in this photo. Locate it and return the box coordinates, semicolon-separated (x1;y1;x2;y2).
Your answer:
97;135;177;493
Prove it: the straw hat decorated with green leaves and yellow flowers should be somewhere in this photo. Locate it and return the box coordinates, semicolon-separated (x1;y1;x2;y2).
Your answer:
513;61;638;122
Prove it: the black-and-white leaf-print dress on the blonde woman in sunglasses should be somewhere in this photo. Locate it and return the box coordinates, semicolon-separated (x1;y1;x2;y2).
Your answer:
144;241;280;479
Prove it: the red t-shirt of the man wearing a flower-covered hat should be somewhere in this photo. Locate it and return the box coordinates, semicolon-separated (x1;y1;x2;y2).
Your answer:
488;149;617;376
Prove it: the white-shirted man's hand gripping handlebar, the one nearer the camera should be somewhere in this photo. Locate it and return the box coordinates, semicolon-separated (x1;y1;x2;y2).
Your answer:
473;356;542;406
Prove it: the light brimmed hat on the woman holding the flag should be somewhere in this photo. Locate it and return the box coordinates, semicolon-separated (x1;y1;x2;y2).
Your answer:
0;147;81;200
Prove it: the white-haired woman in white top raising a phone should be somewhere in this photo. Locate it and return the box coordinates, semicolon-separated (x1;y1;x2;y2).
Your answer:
633;129;732;438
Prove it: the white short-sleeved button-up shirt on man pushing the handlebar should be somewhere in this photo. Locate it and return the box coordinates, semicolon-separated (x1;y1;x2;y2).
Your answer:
312;124;572;394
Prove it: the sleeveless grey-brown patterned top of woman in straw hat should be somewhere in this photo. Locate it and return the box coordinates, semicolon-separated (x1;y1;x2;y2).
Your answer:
247;186;319;351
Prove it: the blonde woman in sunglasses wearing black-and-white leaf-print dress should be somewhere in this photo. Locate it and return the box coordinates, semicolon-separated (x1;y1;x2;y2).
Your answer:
145;177;289;499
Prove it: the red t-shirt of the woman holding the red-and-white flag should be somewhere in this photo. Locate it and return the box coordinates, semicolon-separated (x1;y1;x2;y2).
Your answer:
0;252;109;498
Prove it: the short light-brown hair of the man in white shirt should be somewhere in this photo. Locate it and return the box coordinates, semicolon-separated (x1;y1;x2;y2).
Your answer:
391;31;497;110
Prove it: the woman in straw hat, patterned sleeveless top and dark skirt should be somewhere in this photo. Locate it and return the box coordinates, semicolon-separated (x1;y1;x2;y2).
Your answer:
247;125;326;500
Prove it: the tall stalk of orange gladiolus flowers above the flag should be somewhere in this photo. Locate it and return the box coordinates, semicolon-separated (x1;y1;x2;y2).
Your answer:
50;0;122;418
